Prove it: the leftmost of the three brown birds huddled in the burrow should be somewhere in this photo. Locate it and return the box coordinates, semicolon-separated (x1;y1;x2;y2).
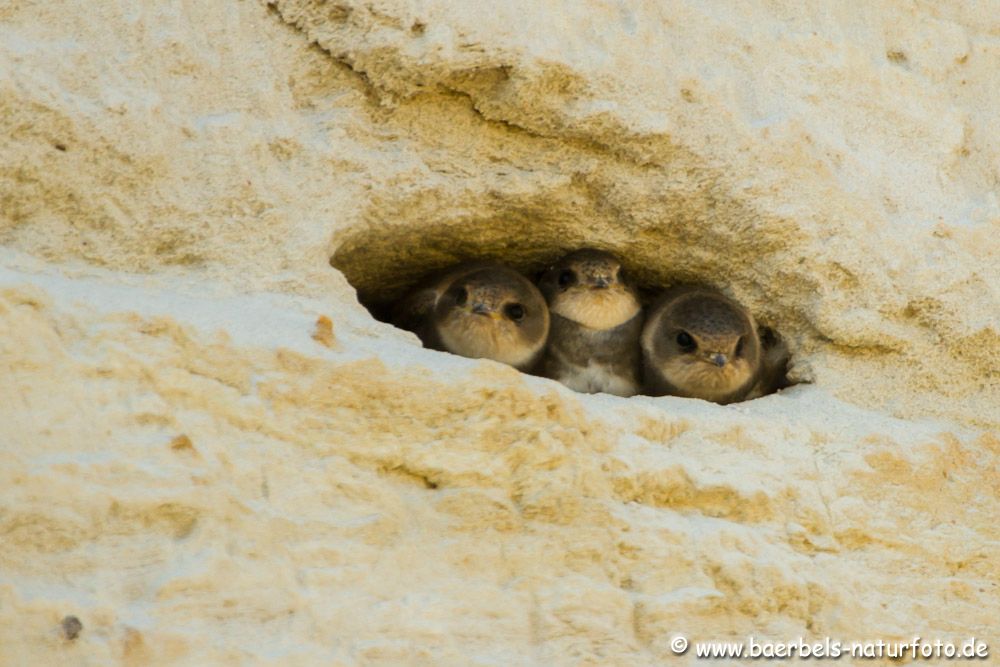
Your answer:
392;262;549;370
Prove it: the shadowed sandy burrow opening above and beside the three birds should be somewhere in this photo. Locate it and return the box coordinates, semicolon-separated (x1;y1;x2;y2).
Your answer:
330;211;792;402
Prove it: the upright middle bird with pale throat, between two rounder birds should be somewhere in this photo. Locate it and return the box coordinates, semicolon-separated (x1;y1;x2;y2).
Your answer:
538;249;642;396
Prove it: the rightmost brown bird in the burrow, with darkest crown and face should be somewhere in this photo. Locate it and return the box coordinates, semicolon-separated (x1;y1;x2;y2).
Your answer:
641;286;761;403
